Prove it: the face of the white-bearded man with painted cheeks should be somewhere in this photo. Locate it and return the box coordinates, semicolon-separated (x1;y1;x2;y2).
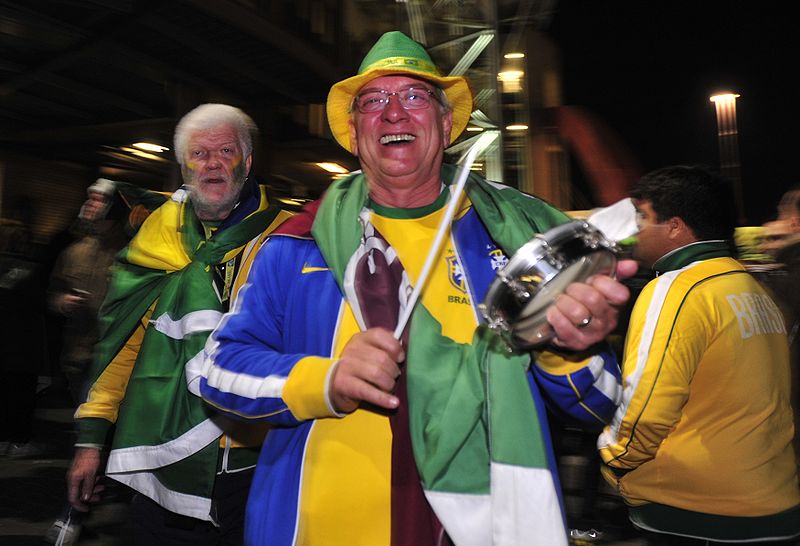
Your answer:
181;125;252;221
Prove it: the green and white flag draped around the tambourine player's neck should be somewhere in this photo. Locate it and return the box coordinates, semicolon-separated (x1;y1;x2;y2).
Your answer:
312;165;568;546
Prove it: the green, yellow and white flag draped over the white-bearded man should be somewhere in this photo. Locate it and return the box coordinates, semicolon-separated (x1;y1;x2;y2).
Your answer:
76;188;280;520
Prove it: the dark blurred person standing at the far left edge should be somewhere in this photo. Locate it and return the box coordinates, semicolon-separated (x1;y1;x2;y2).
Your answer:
0;196;47;457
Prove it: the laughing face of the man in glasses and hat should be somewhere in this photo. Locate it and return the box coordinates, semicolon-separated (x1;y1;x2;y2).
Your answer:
350;76;453;207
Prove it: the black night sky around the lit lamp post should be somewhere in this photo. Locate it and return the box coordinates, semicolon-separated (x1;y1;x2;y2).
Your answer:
547;0;800;225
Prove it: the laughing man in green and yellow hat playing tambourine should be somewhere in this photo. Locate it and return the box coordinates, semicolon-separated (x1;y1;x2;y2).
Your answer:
200;32;633;546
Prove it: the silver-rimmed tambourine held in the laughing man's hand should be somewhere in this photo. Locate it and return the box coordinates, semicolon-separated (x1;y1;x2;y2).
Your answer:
478;220;619;349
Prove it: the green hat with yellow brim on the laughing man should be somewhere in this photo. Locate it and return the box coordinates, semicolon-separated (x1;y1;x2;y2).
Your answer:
327;31;472;152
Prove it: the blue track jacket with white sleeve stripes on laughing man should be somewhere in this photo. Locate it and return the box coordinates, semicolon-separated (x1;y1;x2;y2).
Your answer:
200;202;621;545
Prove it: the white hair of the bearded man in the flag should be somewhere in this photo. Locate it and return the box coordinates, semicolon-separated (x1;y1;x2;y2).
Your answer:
175;103;258;165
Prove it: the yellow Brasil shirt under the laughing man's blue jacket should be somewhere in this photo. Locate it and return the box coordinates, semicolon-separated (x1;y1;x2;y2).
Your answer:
297;193;478;546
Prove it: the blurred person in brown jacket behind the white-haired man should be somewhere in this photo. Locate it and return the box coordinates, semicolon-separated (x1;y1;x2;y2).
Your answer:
47;178;128;406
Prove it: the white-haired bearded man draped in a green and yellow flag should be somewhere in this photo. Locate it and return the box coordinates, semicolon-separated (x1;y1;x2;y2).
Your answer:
67;104;288;546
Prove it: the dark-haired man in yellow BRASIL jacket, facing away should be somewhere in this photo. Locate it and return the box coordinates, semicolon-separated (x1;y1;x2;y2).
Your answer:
598;166;800;545
